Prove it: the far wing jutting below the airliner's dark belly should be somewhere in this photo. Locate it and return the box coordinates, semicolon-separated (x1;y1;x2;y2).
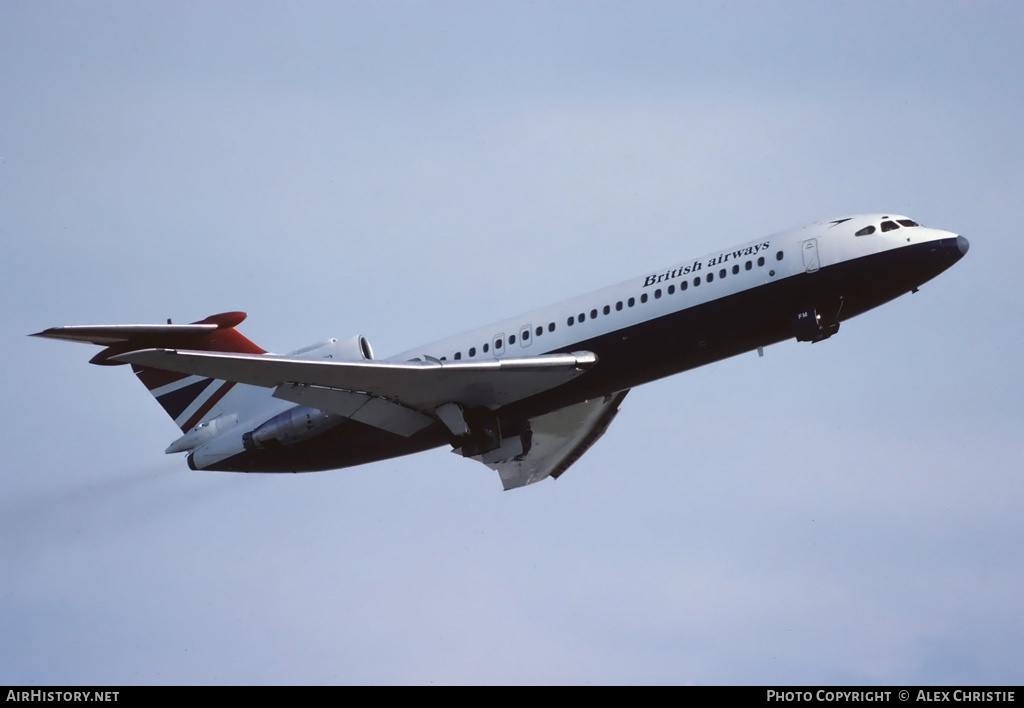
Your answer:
453;390;629;490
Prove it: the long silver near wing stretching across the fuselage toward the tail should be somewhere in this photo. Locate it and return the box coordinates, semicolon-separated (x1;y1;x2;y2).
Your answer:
111;349;597;435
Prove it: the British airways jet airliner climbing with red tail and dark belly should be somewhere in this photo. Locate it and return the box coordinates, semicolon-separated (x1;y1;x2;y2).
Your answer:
32;214;970;490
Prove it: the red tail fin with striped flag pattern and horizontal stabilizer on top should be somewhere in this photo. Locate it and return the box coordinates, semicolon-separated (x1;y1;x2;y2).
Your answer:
33;313;267;431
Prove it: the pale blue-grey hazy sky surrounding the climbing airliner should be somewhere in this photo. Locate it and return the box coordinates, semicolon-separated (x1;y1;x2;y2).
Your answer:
0;1;1024;684
